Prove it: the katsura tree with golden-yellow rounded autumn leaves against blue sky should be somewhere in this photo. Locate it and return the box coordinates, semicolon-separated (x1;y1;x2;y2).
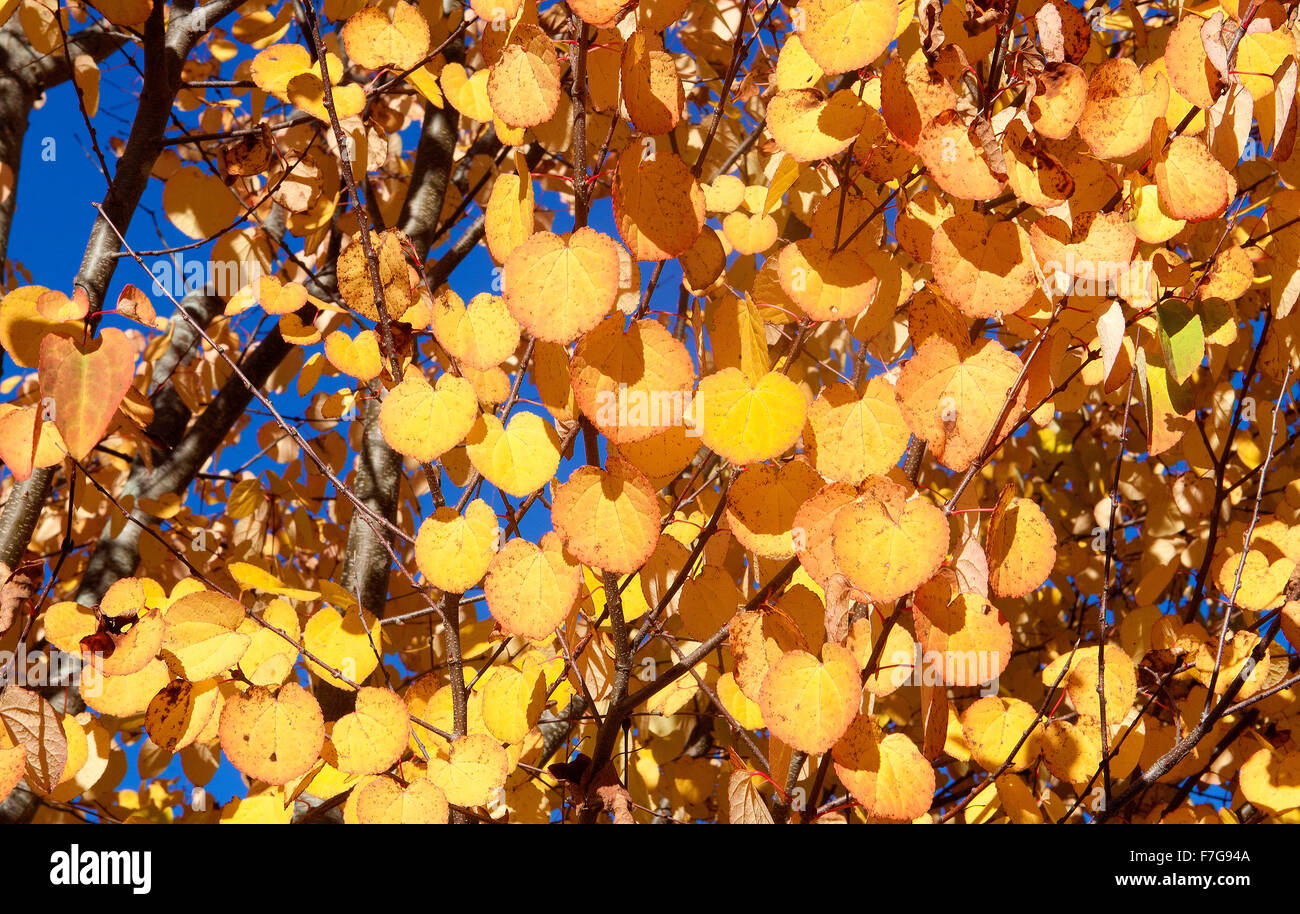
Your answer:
0;0;1300;823
